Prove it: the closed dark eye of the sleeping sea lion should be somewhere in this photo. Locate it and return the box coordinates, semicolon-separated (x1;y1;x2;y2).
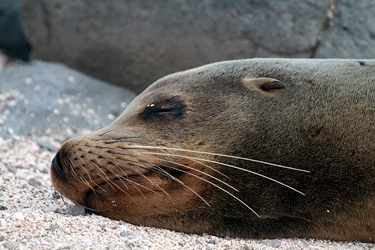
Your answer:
141;98;185;119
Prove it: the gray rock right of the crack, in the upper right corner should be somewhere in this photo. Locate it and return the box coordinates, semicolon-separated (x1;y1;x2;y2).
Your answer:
316;0;375;58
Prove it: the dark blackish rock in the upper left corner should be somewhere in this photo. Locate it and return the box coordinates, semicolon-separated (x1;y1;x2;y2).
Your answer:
0;0;31;60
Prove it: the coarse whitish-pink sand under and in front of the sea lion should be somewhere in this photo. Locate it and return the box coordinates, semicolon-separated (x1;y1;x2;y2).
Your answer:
0;134;375;249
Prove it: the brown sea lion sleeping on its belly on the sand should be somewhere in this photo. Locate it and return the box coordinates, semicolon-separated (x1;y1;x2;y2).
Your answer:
51;59;375;241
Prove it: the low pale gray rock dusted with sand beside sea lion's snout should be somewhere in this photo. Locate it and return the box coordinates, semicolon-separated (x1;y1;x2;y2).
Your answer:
0;61;135;138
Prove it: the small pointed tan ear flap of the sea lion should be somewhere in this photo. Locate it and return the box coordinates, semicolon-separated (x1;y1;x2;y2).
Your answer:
242;77;286;93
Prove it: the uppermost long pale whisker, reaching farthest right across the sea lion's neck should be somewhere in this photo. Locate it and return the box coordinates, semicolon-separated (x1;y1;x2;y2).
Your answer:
128;145;310;173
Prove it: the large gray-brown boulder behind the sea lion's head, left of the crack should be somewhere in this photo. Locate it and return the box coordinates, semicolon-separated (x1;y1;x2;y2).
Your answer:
21;0;331;92
